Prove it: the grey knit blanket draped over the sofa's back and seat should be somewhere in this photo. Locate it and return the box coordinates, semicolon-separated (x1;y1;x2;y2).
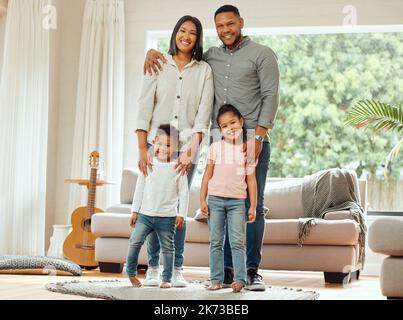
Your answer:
298;168;367;269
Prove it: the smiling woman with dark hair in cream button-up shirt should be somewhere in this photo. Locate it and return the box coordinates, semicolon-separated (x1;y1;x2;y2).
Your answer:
136;16;214;287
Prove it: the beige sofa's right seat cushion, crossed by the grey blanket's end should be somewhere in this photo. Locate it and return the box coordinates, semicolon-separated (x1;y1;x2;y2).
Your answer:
263;219;359;246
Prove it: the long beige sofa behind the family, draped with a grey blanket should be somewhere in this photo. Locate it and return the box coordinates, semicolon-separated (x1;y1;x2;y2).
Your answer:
92;169;367;283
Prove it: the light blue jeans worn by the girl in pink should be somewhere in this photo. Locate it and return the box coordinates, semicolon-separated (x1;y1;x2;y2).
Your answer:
208;196;246;284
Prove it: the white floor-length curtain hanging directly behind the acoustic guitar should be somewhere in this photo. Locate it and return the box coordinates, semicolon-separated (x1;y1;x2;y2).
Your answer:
69;0;125;218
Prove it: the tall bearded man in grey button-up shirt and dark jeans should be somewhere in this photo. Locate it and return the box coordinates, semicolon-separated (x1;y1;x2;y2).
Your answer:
144;5;280;291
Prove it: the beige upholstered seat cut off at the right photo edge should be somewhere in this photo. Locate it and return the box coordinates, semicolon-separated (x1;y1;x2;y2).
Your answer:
368;217;403;299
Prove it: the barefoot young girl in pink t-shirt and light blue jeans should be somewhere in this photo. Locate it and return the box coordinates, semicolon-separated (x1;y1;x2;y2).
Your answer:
200;104;256;292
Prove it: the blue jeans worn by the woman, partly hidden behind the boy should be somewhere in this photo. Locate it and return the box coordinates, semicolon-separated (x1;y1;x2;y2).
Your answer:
147;146;199;268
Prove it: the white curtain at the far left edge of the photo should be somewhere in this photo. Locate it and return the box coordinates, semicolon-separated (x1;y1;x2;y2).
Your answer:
0;0;49;255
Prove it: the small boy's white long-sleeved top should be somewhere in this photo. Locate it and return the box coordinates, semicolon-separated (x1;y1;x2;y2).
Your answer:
132;157;189;217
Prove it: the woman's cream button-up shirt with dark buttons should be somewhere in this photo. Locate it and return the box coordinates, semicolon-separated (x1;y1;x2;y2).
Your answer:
136;55;214;150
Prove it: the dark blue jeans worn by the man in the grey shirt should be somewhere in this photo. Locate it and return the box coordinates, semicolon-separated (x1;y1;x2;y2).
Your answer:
224;142;270;270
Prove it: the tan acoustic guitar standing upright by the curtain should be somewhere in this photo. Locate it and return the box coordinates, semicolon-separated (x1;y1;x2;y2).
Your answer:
63;151;103;270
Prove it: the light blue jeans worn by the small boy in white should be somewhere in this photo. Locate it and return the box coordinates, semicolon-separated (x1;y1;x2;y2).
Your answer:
126;213;176;282
